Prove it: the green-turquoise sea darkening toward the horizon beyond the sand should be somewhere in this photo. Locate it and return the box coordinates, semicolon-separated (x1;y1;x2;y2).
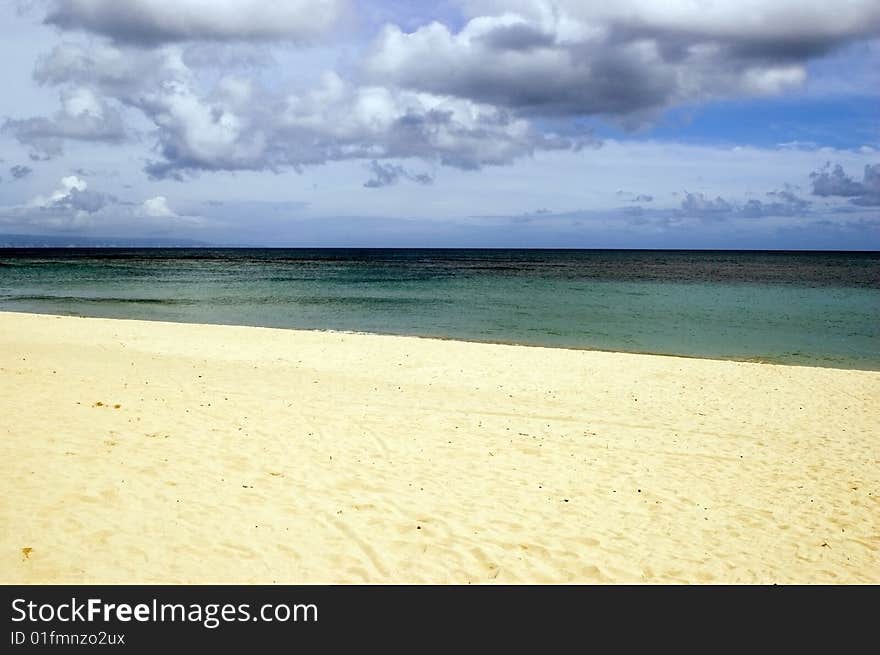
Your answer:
0;248;880;370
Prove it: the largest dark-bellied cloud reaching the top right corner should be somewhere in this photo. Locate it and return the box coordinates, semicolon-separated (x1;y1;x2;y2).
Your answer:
365;0;880;121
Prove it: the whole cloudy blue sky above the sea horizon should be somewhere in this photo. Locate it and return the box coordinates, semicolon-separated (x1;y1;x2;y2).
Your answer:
0;0;880;249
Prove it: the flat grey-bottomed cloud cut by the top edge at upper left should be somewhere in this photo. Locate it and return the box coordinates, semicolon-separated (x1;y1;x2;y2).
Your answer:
45;0;348;45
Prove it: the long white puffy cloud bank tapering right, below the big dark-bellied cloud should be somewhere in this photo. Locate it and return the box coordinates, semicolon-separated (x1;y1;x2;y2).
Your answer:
141;66;592;177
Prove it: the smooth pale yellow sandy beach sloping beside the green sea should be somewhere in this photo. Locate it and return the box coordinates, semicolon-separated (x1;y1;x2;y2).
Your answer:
0;313;880;583
